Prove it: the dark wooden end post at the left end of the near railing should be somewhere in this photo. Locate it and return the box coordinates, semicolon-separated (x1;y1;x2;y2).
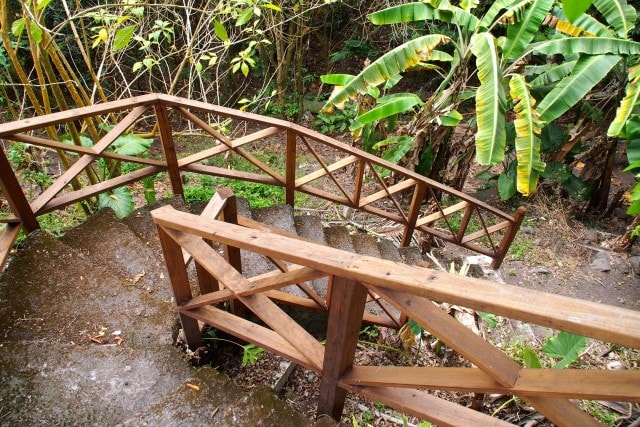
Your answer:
157;225;202;350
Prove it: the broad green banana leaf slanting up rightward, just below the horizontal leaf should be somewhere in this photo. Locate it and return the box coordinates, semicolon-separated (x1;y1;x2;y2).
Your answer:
538;55;620;123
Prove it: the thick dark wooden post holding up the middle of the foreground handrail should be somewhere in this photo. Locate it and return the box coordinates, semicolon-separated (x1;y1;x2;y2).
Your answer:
317;277;367;421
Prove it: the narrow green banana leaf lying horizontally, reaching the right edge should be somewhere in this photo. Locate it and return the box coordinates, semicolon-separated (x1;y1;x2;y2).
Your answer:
530;37;640;55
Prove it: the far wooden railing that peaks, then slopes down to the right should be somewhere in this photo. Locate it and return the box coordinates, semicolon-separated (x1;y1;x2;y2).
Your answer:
0;94;524;268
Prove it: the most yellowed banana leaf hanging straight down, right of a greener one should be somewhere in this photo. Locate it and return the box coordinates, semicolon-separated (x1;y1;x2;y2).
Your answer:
509;74;545;196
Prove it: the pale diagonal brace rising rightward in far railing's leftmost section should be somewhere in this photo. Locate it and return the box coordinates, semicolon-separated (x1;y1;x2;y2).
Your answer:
31;106;147;216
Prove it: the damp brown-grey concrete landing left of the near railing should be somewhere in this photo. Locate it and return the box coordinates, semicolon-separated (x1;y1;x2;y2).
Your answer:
0;206;313;426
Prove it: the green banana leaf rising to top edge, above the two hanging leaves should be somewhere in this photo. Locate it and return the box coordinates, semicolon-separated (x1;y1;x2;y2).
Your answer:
502;0;554;62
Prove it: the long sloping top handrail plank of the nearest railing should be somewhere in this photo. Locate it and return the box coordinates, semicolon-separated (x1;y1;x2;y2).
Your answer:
152;206;640;348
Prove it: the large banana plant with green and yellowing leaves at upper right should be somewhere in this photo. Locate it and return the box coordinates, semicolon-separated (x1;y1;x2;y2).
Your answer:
327;0;640;200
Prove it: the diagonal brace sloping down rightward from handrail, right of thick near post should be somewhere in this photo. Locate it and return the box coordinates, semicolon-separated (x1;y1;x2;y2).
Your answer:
373;287;521;387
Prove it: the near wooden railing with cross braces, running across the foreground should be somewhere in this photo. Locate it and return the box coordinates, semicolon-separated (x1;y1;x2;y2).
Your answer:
152;201;640;426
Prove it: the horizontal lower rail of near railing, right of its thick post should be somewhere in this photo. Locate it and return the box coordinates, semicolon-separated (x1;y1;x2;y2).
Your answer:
340;366;640;402
